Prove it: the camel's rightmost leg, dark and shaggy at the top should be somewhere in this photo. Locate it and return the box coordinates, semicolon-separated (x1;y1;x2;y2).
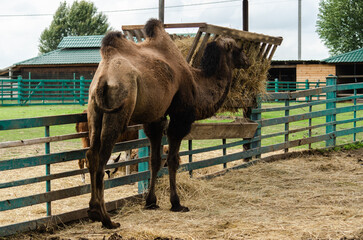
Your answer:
167;118;191;212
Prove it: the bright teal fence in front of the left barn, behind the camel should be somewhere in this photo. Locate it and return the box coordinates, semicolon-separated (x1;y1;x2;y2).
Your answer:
0;76;92;106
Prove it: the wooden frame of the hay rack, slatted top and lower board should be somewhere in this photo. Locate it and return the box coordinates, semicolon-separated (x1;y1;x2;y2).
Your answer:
122;23;282;139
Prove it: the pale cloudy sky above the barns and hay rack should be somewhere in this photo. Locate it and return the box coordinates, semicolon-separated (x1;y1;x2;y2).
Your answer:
0;0;329;69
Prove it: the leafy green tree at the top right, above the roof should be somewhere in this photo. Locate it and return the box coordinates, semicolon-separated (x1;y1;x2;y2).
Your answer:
316;0;363;55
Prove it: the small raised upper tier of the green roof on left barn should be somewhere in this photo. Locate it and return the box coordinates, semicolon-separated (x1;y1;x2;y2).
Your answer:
58;35;104;48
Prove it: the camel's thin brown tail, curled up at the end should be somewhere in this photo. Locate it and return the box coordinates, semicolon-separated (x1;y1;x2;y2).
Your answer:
95;79;125;113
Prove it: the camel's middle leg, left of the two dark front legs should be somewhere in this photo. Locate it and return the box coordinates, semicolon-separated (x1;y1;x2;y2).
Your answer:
144;119;166;209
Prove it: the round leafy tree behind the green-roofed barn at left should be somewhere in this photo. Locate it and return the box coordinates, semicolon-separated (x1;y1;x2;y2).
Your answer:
39;0;110;53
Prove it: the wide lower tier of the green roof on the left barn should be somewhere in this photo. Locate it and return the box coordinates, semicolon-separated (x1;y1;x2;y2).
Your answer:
15;48;101;65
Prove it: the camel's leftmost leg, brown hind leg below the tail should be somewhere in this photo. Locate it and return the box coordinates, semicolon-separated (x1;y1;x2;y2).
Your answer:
86;110;128;228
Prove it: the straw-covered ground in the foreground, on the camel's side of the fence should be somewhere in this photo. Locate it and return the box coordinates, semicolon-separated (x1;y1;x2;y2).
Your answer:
3;149;363;240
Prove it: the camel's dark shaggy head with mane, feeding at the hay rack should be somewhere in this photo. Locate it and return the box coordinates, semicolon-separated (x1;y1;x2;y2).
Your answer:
201;37;250;75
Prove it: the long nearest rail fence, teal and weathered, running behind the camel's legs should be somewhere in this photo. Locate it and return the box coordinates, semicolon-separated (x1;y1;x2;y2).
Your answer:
0;76;363;236
